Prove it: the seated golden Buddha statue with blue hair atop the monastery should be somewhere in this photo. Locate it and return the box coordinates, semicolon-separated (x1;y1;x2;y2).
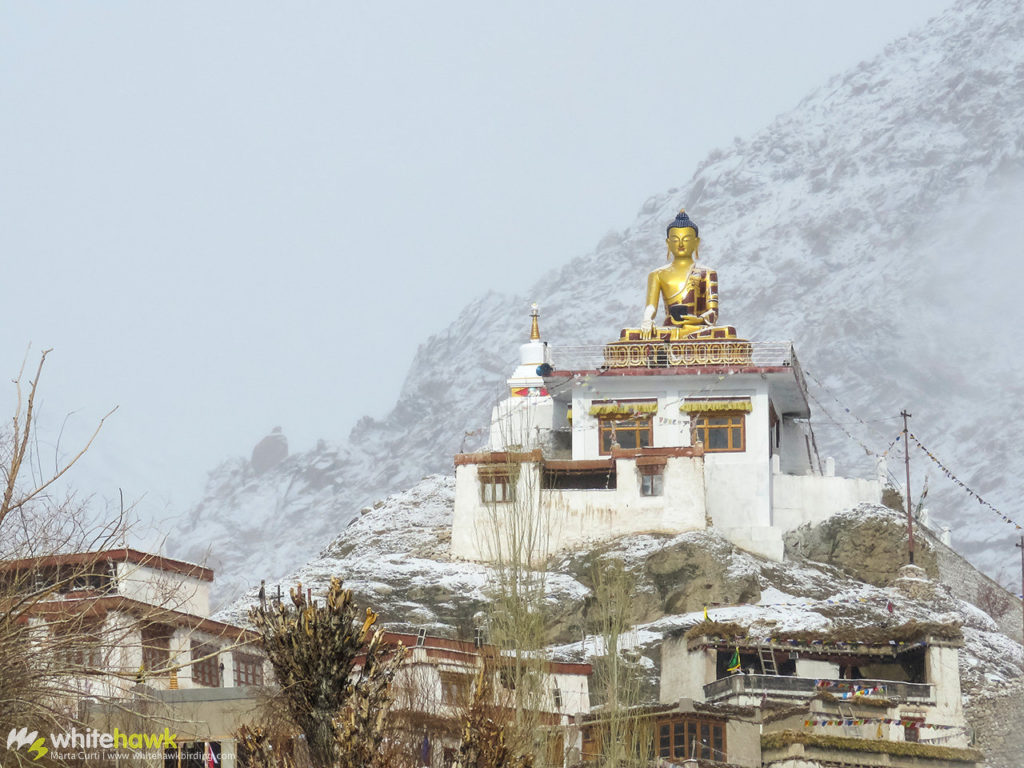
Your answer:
639;211;736;341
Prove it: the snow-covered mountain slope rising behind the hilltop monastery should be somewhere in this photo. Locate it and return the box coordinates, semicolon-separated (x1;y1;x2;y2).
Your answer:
172;0;1024;606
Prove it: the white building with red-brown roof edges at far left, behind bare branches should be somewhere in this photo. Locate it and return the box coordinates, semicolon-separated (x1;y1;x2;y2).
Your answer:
0;549;270;768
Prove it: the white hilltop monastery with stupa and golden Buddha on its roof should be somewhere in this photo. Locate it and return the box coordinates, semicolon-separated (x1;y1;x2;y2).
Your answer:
452;212;884;561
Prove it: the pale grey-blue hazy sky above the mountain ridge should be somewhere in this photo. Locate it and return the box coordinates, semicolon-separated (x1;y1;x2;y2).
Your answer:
0;0;946;528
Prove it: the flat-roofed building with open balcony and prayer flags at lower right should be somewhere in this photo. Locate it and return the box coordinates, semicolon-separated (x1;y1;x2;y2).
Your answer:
660;622;981;768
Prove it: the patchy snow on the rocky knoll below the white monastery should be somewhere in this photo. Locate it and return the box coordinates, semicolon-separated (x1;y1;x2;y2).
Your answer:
216;475;1024;692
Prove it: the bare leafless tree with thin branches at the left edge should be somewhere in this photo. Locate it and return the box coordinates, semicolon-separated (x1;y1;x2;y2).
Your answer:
0;350;127;765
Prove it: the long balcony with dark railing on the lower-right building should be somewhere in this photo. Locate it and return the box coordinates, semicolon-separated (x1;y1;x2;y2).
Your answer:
703;675;935;705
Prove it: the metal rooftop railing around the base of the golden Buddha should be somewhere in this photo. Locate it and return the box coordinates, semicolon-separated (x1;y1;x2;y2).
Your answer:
551;339;799;371
